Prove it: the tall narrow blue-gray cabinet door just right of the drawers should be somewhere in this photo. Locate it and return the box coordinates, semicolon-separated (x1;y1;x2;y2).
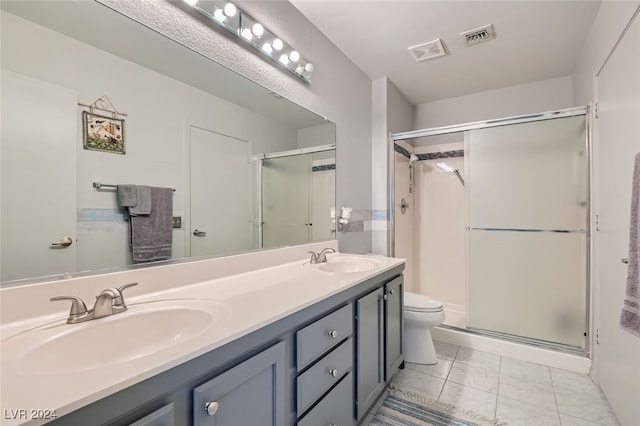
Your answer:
356;288;385;420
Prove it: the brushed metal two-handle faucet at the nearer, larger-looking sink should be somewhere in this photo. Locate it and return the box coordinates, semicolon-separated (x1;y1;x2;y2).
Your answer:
49;283;138;324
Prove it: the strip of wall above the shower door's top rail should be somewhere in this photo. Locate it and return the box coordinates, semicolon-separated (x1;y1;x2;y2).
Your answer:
415;76;577;129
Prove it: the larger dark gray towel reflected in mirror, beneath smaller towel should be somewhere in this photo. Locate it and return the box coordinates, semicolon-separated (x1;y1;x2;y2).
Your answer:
131;187;173;262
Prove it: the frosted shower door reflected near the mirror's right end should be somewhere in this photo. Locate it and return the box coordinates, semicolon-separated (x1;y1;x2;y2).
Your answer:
262;155;312;248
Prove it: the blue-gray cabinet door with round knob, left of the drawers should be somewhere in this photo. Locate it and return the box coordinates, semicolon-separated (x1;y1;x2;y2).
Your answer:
193;342;285;426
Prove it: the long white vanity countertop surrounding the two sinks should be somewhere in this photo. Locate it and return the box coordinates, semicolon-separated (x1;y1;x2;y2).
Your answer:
0;251;404;425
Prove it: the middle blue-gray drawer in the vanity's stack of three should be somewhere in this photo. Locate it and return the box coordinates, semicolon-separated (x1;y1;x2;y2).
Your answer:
296;339;353;416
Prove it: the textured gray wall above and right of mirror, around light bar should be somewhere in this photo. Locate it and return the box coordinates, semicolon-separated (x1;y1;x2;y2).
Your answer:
100;0;371;253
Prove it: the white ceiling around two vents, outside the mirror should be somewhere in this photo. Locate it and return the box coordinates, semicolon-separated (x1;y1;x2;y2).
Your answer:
290;0;601;105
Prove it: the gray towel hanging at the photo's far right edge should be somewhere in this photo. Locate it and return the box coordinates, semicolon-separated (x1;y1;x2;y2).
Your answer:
620;153;640;337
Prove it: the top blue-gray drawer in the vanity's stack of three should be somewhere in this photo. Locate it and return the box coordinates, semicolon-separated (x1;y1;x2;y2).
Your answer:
296;304;353;371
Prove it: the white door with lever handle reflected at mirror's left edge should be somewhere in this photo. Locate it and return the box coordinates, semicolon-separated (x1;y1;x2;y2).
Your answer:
0;69;78;281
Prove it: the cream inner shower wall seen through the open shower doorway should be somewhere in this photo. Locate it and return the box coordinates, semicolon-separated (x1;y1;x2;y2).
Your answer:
395;140;466;327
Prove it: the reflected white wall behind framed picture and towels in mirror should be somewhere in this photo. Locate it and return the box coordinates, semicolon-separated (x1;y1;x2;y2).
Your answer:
2;12;296;270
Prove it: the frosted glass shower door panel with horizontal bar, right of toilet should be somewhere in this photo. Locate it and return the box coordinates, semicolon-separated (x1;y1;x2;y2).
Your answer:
466;116;588;348
